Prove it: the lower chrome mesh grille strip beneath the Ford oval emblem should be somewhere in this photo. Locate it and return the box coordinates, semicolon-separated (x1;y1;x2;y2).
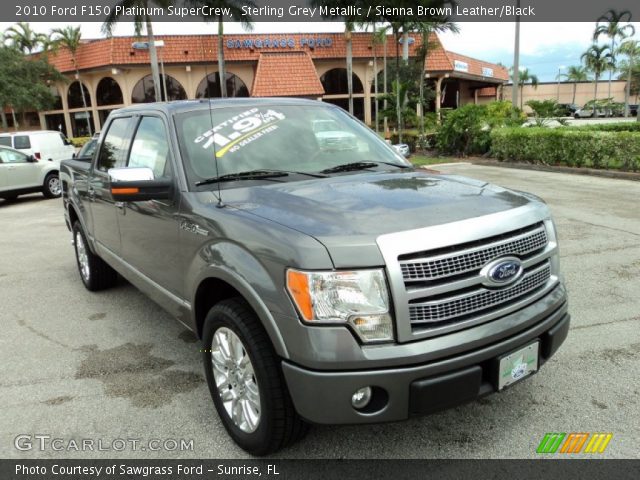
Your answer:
409;260;551;325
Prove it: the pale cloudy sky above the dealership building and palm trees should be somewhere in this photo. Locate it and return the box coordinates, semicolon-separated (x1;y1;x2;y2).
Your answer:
0;22;640;82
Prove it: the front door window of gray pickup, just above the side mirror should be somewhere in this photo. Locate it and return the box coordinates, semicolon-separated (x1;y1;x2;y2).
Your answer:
127;117;169;178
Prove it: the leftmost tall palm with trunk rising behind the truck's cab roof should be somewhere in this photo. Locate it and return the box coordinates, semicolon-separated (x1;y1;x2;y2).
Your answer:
102;0;174;102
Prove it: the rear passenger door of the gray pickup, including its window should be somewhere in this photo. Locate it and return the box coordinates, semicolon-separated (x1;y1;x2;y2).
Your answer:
87;117;134;256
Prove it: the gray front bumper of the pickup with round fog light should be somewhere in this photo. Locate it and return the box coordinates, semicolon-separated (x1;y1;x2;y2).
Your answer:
282;302;570;424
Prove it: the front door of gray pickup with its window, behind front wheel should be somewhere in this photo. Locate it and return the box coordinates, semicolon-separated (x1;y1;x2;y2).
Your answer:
118;115;183;298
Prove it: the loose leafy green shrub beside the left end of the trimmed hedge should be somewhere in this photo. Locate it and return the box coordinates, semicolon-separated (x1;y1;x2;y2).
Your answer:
437;102;525;156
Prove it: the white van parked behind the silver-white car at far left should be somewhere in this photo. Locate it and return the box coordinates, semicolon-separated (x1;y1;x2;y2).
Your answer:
0;130;76;162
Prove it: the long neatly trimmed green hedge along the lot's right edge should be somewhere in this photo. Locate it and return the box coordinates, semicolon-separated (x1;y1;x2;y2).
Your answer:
491;127;640;171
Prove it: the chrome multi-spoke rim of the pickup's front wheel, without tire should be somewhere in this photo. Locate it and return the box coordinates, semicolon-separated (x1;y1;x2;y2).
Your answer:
211;327;261;433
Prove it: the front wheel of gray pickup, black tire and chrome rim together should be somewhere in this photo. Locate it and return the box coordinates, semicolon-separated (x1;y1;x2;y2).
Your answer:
203;298;308;455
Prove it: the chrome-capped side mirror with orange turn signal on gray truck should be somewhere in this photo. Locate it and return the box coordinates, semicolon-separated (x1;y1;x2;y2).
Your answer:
108;167;173;202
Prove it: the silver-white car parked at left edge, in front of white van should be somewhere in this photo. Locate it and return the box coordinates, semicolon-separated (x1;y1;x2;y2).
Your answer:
0;146;61;200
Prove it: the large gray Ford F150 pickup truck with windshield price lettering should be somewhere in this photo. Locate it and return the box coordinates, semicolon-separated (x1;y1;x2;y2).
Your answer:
61;99;569;455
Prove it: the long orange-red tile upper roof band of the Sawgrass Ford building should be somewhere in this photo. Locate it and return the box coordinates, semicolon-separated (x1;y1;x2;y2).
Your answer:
41;32;509;80
